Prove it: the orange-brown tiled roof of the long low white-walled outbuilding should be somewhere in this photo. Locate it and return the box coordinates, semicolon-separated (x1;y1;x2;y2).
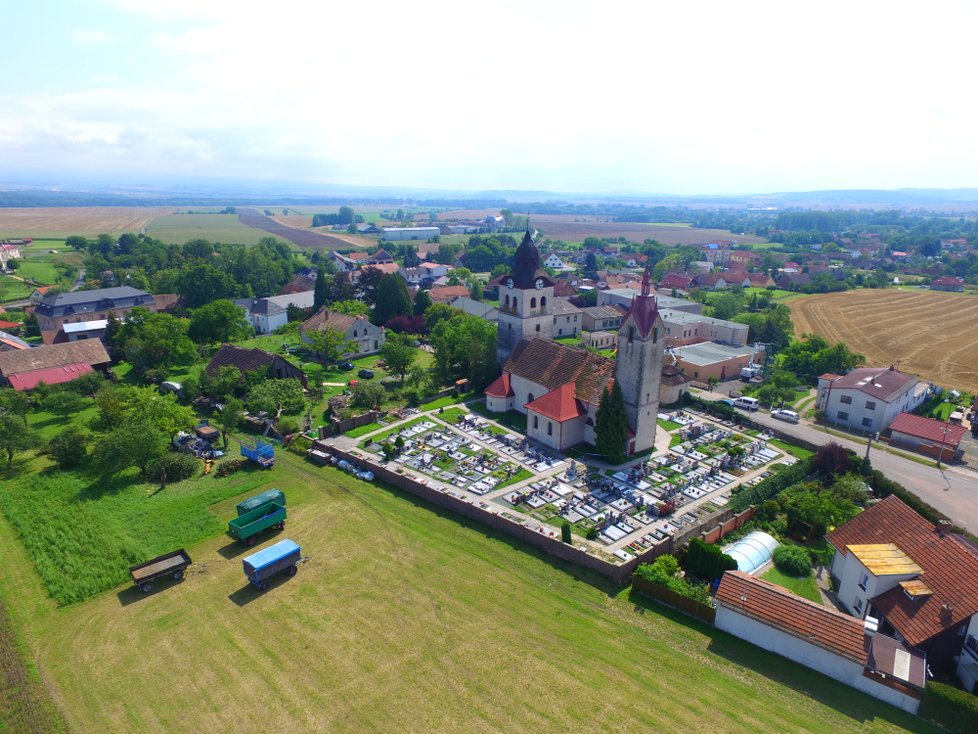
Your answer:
716;571;866;665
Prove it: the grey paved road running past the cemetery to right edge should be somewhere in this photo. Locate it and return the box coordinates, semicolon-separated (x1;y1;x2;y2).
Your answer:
751;412;978;533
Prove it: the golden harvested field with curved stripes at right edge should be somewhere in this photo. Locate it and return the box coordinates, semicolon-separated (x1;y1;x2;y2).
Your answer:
787;289;978;400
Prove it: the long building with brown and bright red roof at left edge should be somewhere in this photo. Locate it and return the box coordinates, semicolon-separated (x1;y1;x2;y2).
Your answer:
0;339;109;390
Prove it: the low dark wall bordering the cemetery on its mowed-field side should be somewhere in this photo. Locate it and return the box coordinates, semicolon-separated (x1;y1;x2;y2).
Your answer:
309;441;754;585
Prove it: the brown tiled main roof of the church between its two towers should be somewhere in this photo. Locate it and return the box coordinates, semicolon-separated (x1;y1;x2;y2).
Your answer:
503;339;615;405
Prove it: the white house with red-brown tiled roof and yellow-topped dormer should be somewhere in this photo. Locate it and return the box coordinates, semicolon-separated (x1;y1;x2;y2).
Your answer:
825;496;978;690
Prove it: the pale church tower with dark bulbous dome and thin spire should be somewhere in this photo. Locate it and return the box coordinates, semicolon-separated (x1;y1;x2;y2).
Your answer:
496;230;554;364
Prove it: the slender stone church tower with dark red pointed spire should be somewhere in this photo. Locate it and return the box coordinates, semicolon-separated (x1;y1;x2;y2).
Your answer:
615;268;666;454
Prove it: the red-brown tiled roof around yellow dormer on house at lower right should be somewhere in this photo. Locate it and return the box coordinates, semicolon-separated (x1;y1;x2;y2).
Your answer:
826;495;978;645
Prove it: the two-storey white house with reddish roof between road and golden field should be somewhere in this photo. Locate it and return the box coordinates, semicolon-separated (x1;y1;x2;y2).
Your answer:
815;366;927;432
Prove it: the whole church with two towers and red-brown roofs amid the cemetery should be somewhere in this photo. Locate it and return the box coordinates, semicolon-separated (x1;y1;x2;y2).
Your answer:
485;232;666;454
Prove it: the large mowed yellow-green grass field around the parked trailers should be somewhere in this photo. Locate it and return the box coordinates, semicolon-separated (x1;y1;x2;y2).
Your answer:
0;454;934;734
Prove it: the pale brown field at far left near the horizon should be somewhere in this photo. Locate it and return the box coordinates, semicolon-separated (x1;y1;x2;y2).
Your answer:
0;206;174;239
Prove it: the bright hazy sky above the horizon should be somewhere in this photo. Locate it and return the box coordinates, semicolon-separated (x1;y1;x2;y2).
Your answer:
0;0;978;195
